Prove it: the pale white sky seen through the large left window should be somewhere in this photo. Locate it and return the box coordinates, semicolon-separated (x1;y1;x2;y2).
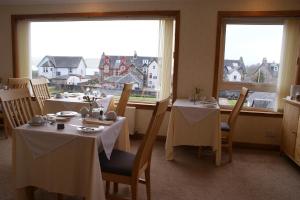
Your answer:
30;20;159;58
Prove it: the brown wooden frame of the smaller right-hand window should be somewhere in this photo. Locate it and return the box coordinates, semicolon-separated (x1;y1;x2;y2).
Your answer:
212;10;300;113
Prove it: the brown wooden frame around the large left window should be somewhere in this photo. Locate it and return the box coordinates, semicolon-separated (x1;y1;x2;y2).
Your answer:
11;10;180;109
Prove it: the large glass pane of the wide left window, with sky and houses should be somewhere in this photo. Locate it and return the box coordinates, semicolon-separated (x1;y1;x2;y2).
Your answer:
30;20;166;102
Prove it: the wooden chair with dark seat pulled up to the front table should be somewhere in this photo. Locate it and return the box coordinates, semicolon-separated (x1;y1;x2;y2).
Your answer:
99;98;169;200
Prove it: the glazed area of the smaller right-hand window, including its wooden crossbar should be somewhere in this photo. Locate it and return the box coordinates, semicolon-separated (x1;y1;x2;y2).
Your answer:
218;23;283;111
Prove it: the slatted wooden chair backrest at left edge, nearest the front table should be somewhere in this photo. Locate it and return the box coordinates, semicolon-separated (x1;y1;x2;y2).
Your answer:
0;88;35;128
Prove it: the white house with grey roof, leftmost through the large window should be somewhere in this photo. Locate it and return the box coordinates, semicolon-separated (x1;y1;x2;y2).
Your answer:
37;56;87;79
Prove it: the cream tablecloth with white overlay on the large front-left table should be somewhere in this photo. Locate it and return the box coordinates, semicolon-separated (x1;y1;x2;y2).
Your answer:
14;118;130;200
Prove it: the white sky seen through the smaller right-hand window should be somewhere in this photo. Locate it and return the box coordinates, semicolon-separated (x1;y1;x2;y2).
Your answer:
225;24;283;66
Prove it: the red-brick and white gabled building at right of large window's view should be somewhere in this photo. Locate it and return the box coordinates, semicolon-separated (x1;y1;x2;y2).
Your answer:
99;52;159;90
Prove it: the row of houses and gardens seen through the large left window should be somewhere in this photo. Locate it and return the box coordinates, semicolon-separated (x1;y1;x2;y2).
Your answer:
33;52;159;98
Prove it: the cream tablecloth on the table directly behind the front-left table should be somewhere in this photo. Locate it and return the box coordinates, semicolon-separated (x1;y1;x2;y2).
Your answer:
45;95;115;113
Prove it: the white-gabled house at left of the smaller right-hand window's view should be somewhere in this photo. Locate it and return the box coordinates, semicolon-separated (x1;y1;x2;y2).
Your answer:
223;57;246;82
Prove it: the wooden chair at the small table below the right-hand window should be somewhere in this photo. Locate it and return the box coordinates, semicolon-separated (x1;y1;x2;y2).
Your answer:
221;87;249;162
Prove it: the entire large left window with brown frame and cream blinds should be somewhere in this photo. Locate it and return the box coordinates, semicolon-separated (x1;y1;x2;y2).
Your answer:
12;11;179;103
